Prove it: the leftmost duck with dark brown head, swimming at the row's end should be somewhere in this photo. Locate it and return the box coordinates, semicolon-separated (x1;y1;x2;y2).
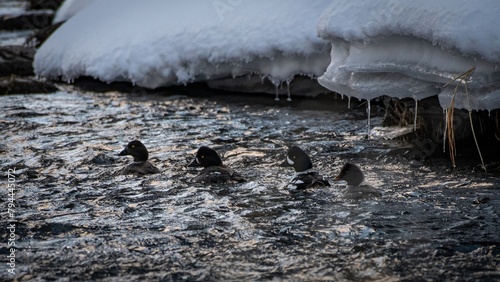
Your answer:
118;140;160;176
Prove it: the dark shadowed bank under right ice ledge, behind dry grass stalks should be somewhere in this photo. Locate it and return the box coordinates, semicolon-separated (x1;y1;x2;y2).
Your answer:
383;97;500;162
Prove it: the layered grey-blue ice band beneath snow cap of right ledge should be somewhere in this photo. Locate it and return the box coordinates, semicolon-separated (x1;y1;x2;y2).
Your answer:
339;36;499;88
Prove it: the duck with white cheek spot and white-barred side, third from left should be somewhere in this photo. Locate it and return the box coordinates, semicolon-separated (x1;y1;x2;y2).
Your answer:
280;146;330;190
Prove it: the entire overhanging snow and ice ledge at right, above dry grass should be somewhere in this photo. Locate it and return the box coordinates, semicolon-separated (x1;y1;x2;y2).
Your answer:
318;0;500;110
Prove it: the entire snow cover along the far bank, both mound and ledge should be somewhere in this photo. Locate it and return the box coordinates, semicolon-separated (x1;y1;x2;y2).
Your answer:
34;0;500;110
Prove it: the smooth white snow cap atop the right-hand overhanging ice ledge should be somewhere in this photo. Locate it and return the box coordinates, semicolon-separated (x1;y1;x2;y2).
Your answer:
318;0;500;63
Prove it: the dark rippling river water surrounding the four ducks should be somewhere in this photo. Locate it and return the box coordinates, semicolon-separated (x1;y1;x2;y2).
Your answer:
0;92;500;281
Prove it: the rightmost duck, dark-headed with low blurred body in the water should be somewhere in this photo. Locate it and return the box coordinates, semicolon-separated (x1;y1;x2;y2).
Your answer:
335;163;382;200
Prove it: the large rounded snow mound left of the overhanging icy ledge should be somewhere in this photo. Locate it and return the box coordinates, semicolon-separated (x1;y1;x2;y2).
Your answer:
34;0;331;88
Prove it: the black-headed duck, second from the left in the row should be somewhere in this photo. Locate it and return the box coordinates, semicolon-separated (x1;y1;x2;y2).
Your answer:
188;146;246;184
